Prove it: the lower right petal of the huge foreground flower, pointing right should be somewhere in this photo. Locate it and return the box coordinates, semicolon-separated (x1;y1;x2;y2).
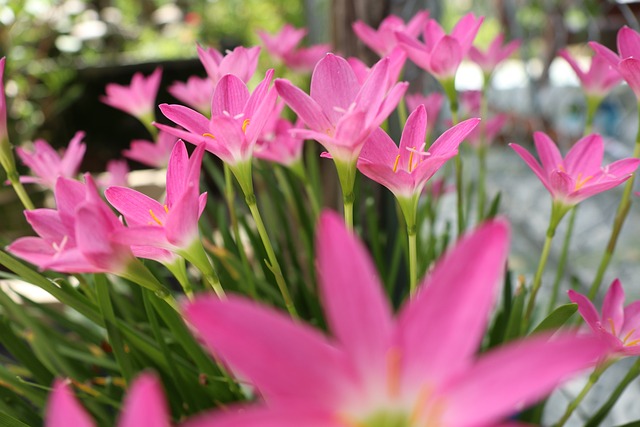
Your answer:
442;334;607;425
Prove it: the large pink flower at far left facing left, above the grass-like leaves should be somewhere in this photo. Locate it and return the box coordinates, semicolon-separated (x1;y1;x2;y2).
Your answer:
7;174;134;275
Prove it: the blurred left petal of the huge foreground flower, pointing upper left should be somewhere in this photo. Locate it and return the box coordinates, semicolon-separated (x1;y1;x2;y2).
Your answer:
183;296;352;408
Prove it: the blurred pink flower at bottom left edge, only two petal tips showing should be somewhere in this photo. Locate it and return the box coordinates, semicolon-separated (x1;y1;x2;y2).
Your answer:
44;373;171;427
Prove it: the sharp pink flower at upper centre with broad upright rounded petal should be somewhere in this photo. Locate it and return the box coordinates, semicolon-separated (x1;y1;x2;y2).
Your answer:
276;54;407;163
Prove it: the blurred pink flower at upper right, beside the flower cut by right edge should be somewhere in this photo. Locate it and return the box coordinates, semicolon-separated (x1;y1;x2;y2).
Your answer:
558;49;622;98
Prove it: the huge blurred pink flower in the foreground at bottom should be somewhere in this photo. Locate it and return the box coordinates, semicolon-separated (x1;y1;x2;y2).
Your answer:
185;213;605;427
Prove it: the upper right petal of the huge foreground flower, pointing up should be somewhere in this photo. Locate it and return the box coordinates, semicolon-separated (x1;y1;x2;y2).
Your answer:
396;221;510;391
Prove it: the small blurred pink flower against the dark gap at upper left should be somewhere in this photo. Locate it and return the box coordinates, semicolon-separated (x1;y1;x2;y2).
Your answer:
100;68;162;122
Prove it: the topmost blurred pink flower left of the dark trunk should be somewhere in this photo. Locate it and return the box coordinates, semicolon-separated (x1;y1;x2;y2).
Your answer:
258;24;331;71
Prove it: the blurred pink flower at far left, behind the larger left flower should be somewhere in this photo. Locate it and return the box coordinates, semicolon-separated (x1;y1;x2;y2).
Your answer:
16;132;87;189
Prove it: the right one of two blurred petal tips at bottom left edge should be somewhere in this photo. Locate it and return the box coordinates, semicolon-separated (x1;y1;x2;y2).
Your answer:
118;373;171;427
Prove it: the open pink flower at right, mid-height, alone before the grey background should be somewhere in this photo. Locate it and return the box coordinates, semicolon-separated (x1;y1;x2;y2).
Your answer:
509;132;640;206
